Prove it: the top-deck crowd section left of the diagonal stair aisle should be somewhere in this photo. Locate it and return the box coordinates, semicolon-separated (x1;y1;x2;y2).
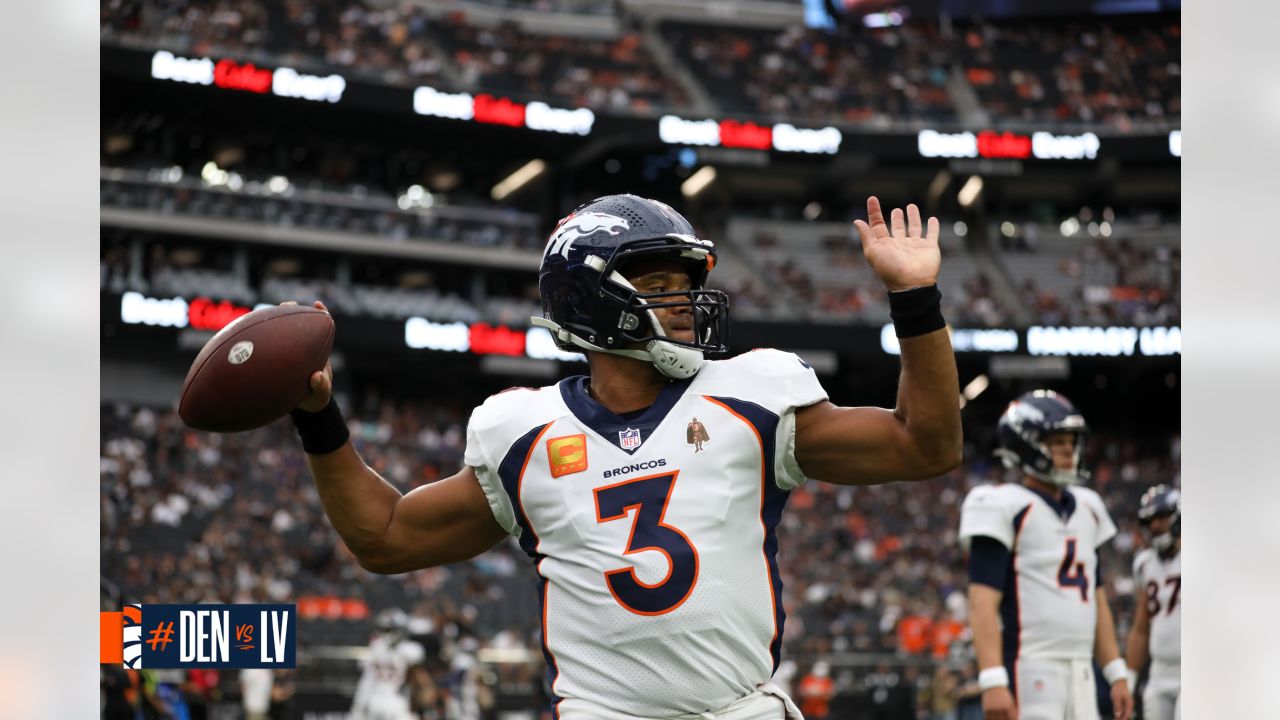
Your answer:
101;0;686;113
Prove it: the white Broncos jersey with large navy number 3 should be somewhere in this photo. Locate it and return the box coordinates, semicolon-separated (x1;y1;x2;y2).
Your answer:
466;350;827;716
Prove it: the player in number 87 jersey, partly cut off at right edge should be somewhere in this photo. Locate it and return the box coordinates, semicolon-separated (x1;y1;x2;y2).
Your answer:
1125;486;1183;720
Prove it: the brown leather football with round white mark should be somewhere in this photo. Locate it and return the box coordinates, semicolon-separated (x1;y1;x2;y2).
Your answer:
178;305;334;433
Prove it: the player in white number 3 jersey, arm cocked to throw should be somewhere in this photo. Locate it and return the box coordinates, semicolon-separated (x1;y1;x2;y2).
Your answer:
293;195;961;720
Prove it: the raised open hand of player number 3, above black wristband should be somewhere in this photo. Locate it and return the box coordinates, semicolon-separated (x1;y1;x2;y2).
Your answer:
854;197;942;291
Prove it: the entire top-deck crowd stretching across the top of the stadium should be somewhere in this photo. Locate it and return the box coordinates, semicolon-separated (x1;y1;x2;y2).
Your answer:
100;0;1181;131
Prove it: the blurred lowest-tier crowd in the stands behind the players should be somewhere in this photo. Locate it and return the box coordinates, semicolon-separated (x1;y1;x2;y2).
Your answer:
100;393;1180;707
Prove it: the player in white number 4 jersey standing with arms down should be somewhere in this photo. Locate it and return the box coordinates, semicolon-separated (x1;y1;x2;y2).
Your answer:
960;389;1133;720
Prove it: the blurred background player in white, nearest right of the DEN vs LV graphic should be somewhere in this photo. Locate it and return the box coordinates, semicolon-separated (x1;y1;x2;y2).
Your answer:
351;607;425;720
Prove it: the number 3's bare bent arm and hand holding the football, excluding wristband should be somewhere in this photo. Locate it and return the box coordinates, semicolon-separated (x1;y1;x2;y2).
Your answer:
298;302;507;574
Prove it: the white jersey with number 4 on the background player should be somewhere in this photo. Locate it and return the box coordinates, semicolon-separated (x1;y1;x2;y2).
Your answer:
960;483;1116;667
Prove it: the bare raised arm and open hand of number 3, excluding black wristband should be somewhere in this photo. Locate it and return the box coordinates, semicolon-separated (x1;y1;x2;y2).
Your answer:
796;197;963;484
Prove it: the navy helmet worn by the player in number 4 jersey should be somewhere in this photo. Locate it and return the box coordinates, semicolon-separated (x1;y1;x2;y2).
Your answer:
996;389;1088;487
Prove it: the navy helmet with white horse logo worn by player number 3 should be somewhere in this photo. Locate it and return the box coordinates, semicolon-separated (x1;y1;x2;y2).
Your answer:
532;195;728;378
